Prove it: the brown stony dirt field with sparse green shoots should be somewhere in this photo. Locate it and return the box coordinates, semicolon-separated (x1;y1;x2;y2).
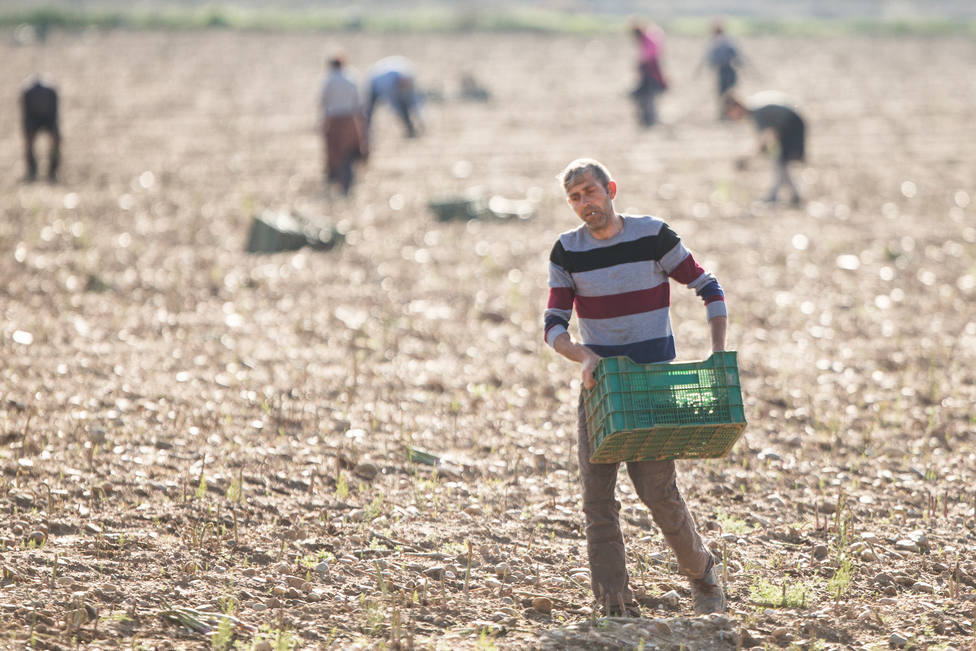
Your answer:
0;26;976;649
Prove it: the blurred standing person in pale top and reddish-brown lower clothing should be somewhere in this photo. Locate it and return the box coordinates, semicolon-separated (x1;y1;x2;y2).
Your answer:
320;53;369;194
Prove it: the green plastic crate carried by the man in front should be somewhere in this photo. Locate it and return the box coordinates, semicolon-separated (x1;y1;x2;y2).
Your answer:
583;351;746;463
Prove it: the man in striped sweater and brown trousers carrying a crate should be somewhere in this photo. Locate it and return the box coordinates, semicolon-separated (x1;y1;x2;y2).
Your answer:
545;159;728;615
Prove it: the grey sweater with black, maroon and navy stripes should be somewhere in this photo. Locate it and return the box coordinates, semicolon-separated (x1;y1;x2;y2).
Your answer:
545;215;726;364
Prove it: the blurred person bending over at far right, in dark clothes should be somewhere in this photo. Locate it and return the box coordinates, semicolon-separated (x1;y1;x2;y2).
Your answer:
724;91;806;205
